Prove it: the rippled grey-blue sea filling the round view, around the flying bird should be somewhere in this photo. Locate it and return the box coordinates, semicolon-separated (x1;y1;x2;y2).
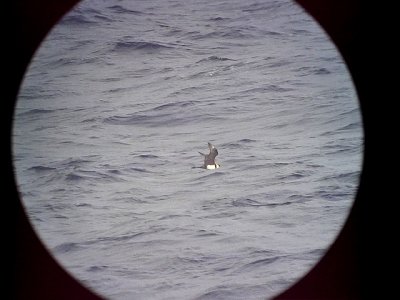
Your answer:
13;0;363;300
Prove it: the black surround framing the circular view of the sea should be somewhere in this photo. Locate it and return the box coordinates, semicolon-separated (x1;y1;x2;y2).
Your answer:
5;0;398;300
